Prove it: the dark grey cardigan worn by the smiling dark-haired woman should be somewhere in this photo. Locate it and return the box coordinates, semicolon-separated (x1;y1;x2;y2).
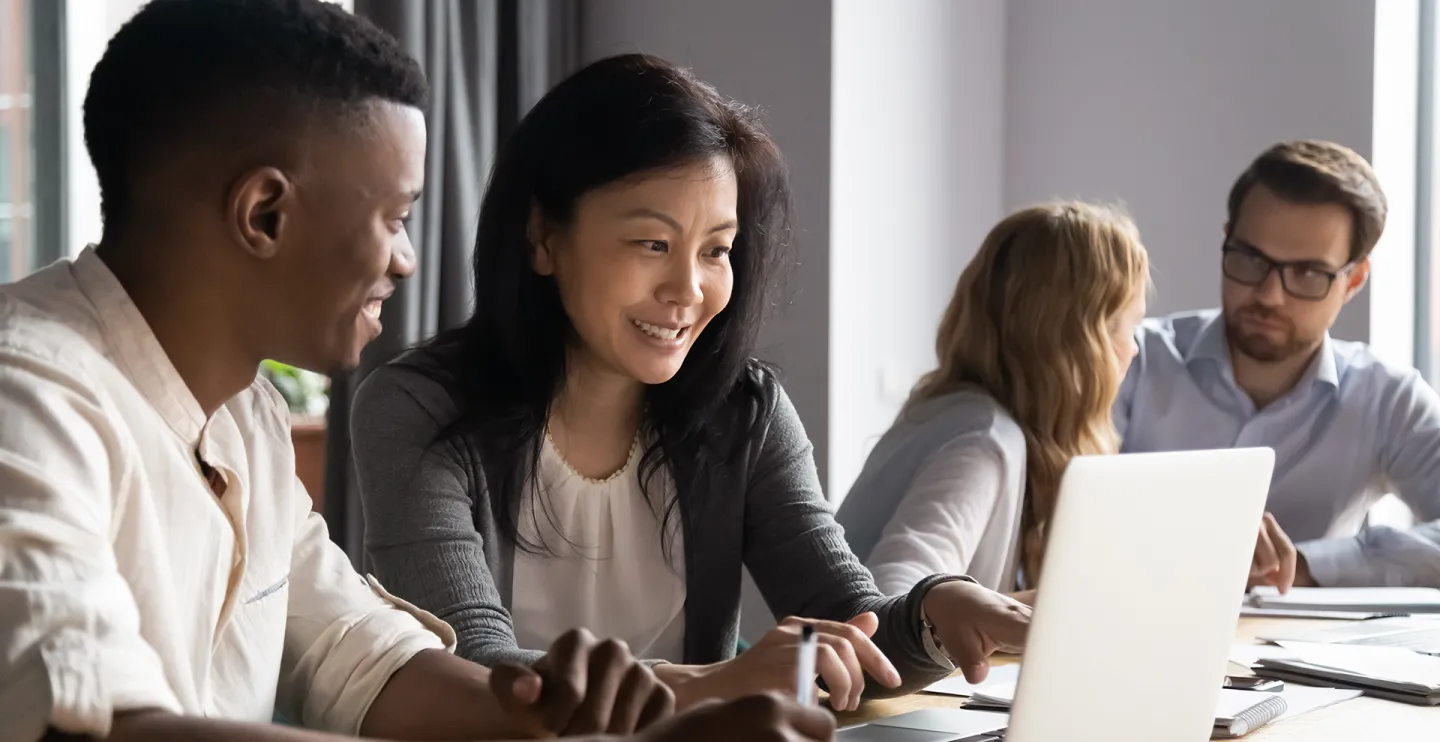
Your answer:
351;350;955;696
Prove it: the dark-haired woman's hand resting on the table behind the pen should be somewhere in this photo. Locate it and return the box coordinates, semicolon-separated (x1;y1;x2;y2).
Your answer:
655;614;900;710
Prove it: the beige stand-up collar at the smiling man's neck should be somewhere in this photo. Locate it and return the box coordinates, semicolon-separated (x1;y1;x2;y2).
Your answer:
71;246;206;442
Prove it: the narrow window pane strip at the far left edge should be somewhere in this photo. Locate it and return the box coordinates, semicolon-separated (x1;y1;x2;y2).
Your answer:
0;0;37;282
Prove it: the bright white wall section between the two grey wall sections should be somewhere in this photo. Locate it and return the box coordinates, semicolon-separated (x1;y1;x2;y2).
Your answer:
828;0;1005;501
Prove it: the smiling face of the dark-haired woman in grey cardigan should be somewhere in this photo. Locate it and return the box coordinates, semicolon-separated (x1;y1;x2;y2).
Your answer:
533;158;737;385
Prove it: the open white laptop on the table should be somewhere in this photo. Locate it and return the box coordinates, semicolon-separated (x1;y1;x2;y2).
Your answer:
837;448;1274;742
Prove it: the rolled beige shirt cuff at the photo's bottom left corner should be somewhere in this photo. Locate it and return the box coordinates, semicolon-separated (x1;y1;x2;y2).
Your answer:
33;628;181;738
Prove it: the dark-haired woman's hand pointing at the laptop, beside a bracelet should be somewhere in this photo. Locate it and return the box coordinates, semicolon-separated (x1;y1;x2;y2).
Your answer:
923;579;1030;683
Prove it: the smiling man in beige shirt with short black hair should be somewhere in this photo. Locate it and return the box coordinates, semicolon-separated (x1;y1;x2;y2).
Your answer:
0;0;832;742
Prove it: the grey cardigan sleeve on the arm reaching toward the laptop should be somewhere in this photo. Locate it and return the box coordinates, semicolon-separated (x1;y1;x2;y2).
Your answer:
744;373;965;697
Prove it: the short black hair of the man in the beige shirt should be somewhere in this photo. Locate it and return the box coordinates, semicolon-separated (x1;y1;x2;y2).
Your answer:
85;0;428;228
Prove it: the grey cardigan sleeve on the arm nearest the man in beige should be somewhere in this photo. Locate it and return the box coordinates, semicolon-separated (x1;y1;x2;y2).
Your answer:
350;365;544;667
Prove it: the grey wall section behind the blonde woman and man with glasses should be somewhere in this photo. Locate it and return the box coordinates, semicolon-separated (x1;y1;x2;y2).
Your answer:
1005;0;1387;340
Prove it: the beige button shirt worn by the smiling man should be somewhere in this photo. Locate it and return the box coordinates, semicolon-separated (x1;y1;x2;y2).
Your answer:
0;249;454;741
